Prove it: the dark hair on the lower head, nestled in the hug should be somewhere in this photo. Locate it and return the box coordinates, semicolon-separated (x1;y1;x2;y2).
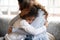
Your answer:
20;7;38;19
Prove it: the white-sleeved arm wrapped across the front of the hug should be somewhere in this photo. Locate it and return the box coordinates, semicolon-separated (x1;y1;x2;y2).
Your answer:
20;20;46;35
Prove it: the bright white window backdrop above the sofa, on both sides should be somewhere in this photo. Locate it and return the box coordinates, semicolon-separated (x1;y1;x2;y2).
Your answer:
0;0;60;22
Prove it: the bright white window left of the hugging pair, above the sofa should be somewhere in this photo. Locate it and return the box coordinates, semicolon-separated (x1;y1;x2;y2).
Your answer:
0;0;19;15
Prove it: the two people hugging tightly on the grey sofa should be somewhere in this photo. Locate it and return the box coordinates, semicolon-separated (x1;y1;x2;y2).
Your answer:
5;0;49;40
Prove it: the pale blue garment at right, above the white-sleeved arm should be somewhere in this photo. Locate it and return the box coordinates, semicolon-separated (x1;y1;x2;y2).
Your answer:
31;9;46;34
